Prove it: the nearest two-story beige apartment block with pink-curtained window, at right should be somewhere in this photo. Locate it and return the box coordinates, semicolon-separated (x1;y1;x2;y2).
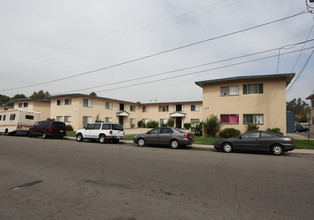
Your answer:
196;74;294;133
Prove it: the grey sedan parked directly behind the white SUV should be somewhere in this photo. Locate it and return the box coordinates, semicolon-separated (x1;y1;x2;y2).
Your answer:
133;127;193;149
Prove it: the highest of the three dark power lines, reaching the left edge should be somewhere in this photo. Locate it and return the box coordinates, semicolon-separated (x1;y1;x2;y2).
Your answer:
0;11;308;91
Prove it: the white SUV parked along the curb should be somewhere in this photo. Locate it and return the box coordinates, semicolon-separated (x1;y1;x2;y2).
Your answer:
76;123;124;143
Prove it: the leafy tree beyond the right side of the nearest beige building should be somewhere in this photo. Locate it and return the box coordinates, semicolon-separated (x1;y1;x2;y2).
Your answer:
286;98;310;122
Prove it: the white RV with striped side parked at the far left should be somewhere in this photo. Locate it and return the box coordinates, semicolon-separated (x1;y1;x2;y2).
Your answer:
0;109;40;135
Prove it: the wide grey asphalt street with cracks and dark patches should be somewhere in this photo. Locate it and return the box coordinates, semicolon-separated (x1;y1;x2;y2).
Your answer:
0;136;314;219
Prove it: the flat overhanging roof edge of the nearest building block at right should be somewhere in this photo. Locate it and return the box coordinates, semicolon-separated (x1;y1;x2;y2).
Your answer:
195;73;295;87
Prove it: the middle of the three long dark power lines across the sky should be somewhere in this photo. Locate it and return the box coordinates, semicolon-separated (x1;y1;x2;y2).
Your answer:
63;39;314;93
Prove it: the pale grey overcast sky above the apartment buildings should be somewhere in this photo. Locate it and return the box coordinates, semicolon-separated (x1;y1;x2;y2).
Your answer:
0;0;314;102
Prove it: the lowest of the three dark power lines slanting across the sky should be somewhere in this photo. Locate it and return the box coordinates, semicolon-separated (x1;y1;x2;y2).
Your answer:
91;46;314;93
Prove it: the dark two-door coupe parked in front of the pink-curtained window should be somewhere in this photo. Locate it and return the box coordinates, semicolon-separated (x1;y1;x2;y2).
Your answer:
214;131;295;155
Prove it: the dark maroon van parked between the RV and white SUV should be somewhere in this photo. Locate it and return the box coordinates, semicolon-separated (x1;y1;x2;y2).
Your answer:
28;121;67;139
